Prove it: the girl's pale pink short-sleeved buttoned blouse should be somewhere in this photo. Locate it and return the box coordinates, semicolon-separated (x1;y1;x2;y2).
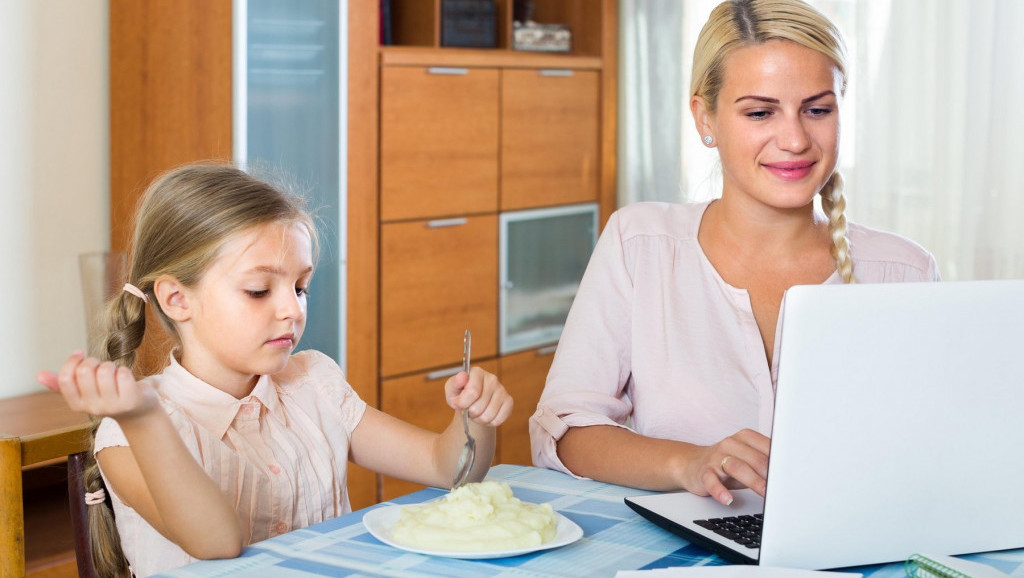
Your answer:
93;350;367;576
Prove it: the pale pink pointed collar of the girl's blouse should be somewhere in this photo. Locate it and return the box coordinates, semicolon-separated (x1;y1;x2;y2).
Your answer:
160;352;281;439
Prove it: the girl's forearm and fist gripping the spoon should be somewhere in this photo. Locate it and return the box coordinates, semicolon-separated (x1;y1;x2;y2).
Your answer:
350;367;512;488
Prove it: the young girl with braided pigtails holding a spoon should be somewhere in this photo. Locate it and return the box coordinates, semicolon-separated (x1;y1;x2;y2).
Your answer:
38;165;512;576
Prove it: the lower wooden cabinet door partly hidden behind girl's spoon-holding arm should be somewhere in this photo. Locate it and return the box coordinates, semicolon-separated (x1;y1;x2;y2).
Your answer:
381;360;498;500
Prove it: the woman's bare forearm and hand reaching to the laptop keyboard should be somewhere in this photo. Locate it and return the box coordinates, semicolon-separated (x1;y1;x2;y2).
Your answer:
557;425;770;504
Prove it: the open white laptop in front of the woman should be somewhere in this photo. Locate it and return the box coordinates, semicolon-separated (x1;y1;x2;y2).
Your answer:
626;281;1024;570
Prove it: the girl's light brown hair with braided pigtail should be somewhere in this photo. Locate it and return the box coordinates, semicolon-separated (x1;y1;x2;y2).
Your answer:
83;164;317;576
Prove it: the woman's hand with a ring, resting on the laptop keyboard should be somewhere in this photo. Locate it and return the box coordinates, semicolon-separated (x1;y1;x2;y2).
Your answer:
684;429;770;505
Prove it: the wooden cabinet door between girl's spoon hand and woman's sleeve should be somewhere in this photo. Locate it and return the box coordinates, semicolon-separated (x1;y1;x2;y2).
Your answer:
498;345;555;465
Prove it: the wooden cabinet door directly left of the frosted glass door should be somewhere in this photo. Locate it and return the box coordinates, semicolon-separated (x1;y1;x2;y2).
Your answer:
381;214;498;377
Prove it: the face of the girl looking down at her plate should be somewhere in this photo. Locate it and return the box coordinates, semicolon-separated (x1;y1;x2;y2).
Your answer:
179;223;313;393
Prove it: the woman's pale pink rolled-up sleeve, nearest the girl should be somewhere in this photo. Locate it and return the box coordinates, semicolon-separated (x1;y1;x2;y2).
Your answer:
529;213;633;473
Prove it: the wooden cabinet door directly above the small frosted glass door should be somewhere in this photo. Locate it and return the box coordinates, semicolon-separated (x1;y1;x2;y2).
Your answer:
501;69;600;210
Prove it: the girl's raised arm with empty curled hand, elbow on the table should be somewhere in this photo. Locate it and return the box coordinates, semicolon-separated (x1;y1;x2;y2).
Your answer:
38;352;245;559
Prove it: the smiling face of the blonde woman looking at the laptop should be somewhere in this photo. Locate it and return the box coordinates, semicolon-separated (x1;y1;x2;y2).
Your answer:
691;40;842;209
